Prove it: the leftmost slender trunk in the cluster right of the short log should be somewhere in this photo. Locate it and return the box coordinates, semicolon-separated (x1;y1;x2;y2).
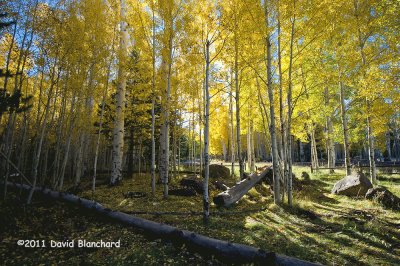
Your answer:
264;2;280;204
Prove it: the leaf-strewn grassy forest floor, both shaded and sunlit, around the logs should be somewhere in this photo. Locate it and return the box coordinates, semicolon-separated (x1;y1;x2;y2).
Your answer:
0;167;400;265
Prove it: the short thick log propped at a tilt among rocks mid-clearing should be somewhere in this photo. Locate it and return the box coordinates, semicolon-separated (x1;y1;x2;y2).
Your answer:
213;167;272;207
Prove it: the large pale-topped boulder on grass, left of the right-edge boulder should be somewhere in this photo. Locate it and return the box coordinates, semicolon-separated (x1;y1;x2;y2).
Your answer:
332;172;372;197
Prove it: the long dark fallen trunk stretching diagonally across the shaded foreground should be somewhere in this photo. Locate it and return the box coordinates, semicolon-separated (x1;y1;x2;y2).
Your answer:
3;182;316;266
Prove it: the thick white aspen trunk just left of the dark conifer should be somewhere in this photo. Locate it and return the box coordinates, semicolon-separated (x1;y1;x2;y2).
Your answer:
110;0;128;185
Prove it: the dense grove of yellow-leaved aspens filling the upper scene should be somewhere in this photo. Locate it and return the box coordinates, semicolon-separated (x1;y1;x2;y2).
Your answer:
0;0;400;208
